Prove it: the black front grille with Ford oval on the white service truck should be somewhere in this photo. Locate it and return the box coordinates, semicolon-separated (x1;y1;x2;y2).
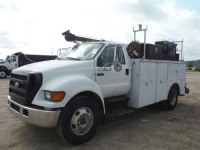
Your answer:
9;73;42;106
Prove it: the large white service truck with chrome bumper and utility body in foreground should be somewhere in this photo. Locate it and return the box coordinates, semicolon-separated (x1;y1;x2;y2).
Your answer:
8;32;188;145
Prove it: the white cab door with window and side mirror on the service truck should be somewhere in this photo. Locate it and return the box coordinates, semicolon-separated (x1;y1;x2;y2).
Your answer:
96;45;131;98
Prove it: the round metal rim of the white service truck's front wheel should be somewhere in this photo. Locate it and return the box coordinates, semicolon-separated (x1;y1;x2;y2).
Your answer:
71;107;94;135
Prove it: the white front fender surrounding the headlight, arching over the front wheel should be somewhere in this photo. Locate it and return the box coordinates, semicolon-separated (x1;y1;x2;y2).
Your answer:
32;75;105;111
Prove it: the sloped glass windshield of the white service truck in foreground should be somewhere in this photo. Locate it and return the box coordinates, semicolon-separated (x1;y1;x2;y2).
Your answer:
58;43;104;60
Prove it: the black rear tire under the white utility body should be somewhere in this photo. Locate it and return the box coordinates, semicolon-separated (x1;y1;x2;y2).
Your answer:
162;86;178;110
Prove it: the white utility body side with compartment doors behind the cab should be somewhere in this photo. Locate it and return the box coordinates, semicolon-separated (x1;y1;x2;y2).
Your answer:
128;59;186;108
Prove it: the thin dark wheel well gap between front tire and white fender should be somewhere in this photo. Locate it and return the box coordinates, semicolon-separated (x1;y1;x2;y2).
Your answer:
67;91;104;116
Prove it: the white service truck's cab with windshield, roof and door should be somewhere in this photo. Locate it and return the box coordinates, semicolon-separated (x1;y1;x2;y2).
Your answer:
55;42;131;98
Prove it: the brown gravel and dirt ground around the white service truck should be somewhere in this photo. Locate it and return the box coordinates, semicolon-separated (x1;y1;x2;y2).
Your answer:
0;73;200;150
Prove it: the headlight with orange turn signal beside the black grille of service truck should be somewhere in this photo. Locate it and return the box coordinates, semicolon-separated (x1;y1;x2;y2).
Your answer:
44;91;65;102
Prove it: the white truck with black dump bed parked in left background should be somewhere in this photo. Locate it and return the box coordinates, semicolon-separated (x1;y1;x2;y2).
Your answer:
0;52;57;78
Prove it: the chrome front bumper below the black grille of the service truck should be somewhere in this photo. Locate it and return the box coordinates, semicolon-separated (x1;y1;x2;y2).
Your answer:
8;96;61;128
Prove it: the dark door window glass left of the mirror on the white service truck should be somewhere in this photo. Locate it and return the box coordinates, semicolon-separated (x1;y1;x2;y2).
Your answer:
97;45;115;67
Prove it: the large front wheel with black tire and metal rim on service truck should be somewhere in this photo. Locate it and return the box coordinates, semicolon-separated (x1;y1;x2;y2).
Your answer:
57;96;100;145
